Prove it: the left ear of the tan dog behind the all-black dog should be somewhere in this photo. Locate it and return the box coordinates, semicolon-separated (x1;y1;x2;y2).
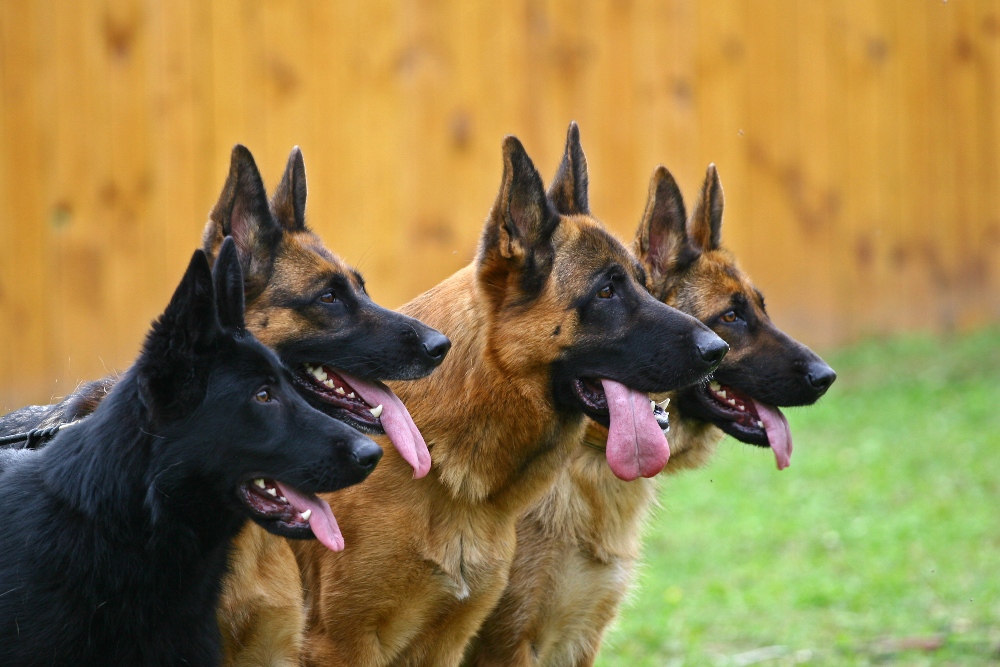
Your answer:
202;144;282;294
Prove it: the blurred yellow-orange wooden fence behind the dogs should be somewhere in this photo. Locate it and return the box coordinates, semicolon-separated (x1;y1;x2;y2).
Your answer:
0;0;1000;409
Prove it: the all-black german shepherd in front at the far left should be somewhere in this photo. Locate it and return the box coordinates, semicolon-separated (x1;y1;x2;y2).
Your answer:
0;240;382;667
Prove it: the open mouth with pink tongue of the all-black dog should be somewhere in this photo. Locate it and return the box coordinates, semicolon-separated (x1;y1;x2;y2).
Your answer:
239;477;344;551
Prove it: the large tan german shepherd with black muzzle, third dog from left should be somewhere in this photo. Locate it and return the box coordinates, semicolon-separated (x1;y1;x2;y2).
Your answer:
221;125;726;667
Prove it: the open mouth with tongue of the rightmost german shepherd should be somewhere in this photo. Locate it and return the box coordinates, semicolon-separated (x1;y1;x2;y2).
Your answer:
698;380;792;470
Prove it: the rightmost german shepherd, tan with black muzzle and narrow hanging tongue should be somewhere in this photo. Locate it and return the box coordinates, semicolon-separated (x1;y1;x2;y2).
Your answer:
465;165;836;667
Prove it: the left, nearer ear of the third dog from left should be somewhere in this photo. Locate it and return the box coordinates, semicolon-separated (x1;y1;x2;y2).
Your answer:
477;136;560;301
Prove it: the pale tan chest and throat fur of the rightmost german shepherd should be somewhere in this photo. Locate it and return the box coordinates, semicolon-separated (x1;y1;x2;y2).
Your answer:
465;414;722;667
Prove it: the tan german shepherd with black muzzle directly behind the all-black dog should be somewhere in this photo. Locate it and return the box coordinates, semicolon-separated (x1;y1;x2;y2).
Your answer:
0;146;451;665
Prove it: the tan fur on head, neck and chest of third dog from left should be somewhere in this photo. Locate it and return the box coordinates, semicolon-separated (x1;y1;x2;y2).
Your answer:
218;139;641;667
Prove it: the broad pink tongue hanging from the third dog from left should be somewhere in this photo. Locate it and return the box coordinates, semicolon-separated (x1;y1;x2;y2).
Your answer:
601;380;670;482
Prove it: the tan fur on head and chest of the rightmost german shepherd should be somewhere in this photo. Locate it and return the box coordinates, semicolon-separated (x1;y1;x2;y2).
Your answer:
464;168;784;667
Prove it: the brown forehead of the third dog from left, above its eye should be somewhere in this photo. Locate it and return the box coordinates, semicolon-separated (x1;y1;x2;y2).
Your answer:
555;215;646;284
